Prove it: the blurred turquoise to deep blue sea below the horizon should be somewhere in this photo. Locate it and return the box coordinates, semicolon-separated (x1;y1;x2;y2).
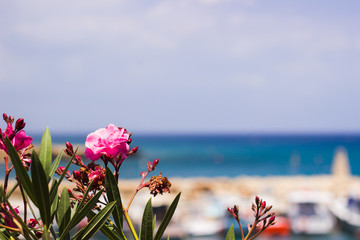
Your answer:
23;134;360;178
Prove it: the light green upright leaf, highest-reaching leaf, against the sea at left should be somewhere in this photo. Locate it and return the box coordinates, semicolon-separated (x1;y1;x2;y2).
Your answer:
39;128;52;179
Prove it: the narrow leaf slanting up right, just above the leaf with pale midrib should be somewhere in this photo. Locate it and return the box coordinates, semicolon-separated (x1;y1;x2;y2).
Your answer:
59;190;103;240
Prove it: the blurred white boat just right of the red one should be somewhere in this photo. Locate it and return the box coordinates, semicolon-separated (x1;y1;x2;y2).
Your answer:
288;191;335;235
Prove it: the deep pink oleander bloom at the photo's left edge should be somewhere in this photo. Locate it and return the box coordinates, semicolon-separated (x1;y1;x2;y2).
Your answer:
0;123;33;153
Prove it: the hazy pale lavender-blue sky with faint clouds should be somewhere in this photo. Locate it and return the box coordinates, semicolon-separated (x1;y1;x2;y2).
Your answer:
0;0;360;133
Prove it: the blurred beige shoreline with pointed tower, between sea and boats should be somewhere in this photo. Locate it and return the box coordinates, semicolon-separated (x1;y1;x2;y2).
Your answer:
0;144;360;215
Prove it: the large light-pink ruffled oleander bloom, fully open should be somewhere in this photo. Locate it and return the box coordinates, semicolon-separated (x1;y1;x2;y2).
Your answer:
85;124;129;161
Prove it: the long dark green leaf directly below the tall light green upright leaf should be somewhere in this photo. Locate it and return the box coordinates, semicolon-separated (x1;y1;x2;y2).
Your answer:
31;151;51;227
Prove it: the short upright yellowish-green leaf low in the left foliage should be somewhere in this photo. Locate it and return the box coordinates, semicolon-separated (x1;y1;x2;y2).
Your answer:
57;187;71;239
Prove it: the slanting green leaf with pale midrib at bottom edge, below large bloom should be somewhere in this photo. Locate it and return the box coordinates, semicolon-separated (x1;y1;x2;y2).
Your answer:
73;202;115;240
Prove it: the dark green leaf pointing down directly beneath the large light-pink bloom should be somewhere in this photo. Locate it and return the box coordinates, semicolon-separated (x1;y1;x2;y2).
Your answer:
105;167;123;231
